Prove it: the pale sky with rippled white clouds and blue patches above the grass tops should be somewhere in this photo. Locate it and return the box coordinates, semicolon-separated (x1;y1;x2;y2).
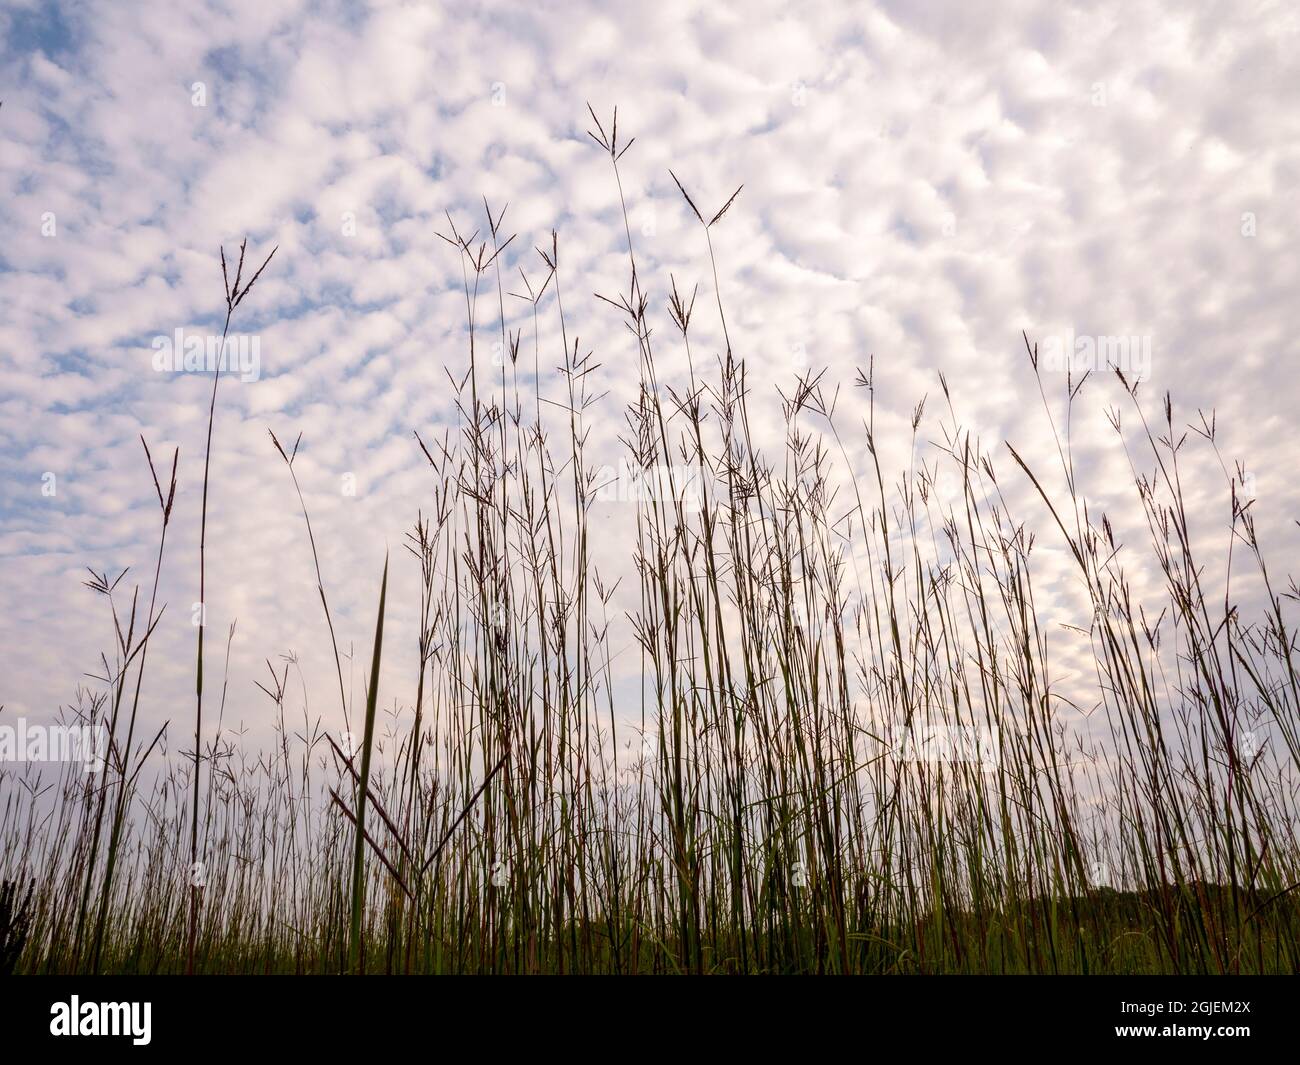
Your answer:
0;0;1300;764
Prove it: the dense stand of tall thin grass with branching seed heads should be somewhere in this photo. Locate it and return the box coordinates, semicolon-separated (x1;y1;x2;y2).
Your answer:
0;113;1300;973
